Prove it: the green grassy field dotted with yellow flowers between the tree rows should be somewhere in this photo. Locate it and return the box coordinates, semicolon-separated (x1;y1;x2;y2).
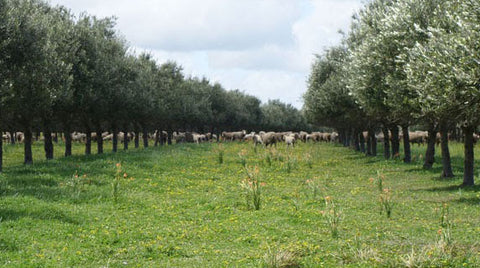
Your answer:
0;140;480;267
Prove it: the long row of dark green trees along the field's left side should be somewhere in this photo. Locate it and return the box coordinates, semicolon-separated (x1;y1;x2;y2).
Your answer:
0;0;308;171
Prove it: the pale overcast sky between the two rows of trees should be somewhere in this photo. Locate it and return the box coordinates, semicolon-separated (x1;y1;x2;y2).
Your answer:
50;0;365;108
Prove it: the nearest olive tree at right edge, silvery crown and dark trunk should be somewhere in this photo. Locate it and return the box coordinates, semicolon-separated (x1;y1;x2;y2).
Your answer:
405;0;480;185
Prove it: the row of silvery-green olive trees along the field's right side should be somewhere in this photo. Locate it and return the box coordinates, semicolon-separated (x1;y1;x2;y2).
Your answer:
304;0;480;185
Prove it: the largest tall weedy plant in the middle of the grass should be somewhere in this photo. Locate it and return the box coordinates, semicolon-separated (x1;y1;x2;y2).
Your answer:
240;166;265;210
